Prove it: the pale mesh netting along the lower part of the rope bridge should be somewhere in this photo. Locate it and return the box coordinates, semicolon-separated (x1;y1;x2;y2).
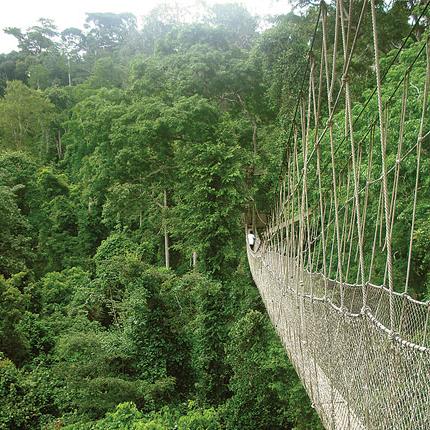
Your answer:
248;250;430;430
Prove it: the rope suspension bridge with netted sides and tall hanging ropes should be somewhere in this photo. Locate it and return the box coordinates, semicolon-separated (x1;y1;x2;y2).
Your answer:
248;0;430;430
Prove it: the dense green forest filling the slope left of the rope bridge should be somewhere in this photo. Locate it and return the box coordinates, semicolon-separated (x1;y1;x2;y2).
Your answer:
0;1;430;430
